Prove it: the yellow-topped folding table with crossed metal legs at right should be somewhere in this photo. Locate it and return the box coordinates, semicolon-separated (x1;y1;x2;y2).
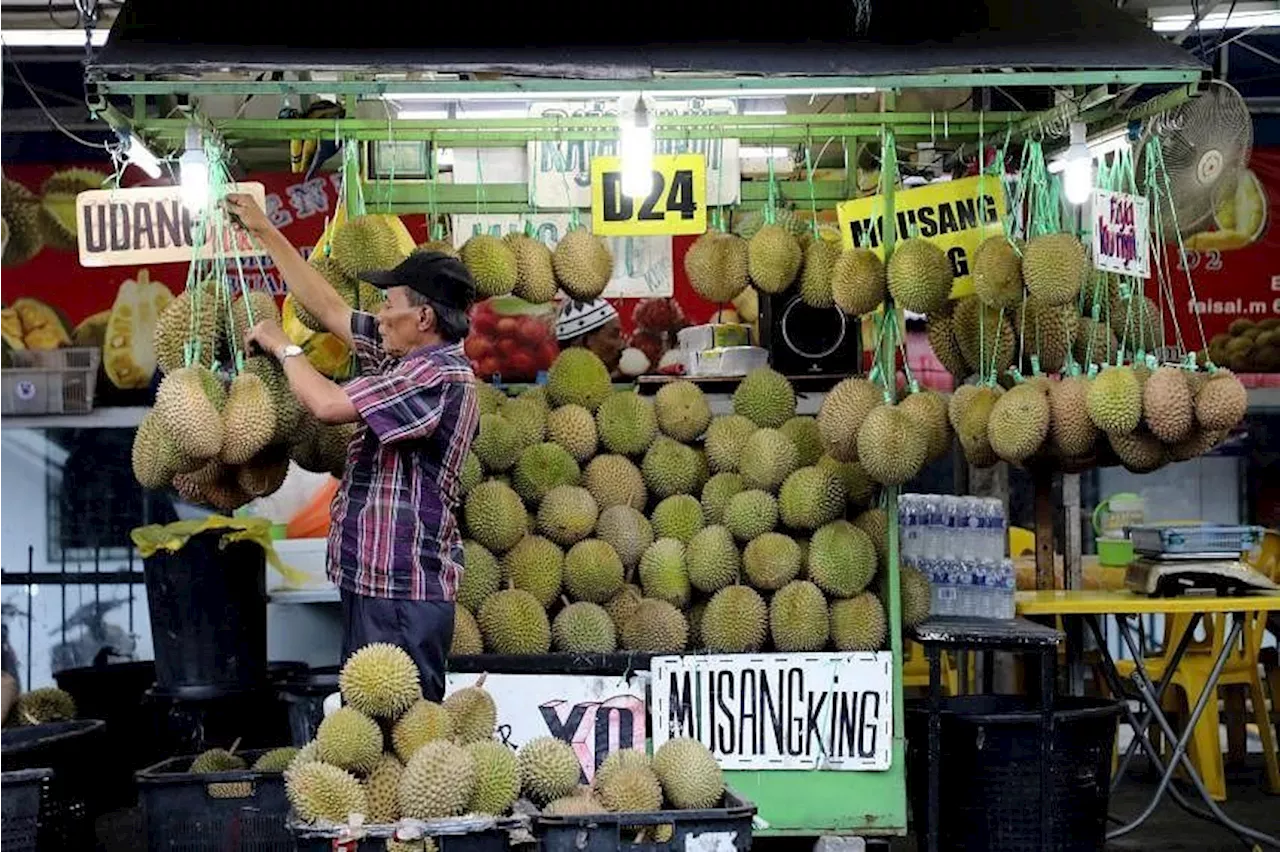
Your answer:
1016;590;1280;849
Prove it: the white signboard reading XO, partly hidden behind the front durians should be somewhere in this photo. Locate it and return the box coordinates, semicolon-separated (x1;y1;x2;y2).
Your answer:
444;673;649;783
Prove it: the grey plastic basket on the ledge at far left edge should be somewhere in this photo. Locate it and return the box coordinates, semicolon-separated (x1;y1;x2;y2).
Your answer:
0;347;102;414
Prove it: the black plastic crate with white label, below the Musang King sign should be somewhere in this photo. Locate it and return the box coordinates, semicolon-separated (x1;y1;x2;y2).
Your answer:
534;789;755;852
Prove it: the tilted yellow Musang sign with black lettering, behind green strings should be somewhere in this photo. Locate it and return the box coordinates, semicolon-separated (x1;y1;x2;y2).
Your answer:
836;175;1005;298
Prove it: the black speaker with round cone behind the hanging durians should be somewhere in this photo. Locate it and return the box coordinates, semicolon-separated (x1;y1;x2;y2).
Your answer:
760;288;863;376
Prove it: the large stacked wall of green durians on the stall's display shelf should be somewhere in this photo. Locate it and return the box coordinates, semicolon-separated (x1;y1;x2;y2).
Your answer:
453;348;931;655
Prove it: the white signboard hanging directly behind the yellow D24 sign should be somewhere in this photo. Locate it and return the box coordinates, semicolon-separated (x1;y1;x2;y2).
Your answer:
529;99;741;209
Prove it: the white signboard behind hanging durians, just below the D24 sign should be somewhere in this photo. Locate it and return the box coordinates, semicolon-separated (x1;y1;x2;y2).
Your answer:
451;212;676;299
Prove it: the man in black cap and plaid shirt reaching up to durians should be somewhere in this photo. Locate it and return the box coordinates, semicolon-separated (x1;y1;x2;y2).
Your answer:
227;194;480;701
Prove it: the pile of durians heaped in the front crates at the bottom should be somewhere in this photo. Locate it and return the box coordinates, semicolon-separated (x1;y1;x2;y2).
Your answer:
284;643;724;849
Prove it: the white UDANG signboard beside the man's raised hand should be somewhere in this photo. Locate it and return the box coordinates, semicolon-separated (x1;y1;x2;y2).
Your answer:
76;183;266;267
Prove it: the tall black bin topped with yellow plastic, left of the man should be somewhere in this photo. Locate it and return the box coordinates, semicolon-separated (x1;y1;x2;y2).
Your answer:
143;530;269;700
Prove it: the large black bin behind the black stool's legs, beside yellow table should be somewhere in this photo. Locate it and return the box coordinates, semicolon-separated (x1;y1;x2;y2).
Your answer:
906;695;1120;852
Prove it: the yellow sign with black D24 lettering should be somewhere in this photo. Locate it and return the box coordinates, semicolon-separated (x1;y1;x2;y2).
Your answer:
591;154;707;237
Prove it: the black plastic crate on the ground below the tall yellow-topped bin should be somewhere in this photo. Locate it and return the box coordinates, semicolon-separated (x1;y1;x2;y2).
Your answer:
136;750;293;852
